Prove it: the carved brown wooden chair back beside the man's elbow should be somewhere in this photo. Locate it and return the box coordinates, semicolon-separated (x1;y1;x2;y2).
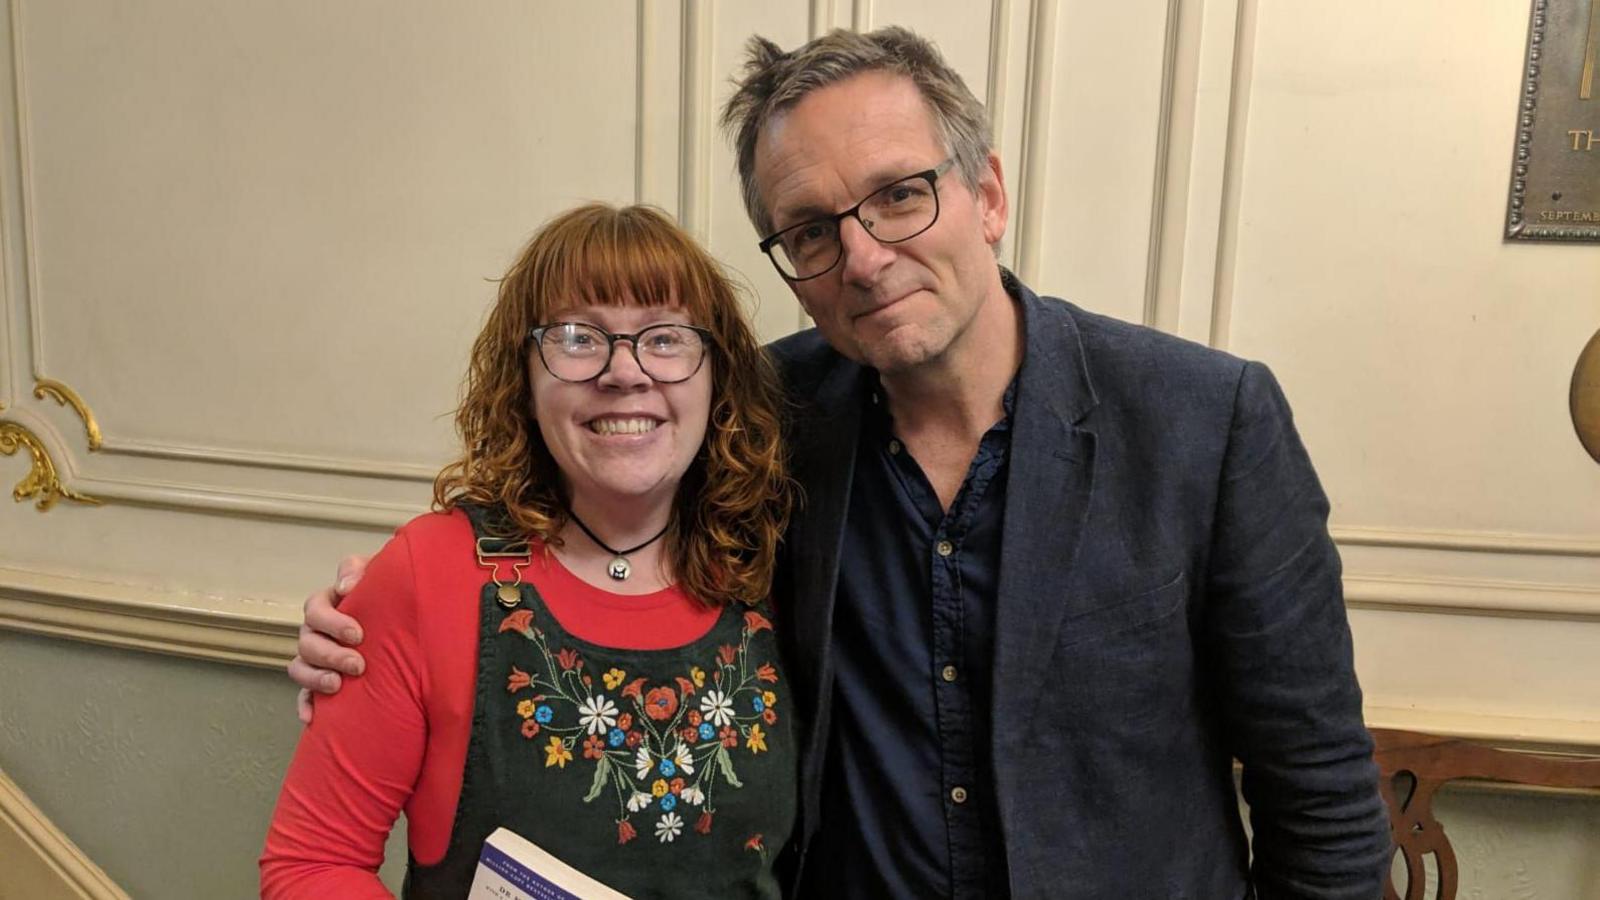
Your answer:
1373;729;1600;900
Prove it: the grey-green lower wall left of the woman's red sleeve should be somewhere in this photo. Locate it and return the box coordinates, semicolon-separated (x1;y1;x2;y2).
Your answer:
0;631;405;900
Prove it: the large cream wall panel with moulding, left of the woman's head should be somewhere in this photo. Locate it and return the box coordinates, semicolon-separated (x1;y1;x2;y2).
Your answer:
3;0;656;525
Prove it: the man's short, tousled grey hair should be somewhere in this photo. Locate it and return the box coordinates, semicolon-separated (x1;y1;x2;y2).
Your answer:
722;26;994;234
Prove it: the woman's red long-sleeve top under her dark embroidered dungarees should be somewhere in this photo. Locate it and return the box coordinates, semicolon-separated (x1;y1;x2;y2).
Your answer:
261;511;718;900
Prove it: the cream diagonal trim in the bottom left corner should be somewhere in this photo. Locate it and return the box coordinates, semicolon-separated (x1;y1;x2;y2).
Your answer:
0;762;128;900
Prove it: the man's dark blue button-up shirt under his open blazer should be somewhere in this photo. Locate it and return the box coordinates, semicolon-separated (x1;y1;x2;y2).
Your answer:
806;374;1014;898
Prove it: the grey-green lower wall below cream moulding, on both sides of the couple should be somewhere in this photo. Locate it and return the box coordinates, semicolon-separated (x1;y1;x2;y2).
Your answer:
0;631;1600;900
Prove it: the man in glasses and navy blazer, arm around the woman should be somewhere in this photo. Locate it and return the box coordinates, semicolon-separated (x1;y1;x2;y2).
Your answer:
291;29;1389;898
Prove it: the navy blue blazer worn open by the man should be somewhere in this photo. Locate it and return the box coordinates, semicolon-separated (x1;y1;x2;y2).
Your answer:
771;274;1389;900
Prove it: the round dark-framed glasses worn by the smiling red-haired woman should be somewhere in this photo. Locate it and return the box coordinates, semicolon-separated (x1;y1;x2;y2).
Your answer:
528;322;712;384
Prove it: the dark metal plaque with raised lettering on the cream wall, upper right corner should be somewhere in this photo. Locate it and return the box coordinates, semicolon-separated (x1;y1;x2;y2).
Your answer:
1506;0;1600;242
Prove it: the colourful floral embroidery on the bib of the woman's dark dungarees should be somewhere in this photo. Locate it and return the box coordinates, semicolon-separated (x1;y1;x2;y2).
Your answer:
499;609;779;854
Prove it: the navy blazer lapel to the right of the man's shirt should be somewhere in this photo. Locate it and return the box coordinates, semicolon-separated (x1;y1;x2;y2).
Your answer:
994;285;1096;733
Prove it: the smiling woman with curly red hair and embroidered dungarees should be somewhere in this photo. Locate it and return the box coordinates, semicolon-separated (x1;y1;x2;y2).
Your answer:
261;205;795;897
